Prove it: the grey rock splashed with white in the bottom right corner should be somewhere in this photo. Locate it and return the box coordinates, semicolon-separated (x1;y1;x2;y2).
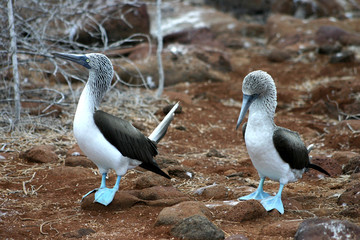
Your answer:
294;218;360;240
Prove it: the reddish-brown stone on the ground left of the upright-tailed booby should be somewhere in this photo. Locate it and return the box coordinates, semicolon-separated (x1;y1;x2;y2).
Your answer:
20;145;59;163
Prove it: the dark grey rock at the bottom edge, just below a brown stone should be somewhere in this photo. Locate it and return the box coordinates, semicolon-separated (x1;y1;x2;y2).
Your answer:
171;215;225;240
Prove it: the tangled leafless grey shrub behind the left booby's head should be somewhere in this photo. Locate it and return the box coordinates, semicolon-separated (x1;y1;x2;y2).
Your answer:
0;0;163;140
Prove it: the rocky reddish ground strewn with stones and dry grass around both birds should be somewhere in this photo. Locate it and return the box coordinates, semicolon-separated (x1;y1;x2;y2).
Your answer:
0;1;360;240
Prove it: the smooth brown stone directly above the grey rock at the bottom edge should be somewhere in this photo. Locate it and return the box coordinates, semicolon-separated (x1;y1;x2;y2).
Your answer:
155;201;211;226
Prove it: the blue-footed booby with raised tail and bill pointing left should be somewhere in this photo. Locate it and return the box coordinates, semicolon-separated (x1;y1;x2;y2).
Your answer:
54;53;178;206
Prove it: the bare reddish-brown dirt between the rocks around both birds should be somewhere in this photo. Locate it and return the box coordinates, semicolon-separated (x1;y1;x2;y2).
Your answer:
0;27;360;240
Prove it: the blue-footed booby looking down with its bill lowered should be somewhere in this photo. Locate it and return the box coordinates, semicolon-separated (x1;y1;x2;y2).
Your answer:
236;70;329;214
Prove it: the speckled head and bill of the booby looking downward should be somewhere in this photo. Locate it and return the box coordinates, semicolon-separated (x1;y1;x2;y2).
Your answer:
236;70;276;129
